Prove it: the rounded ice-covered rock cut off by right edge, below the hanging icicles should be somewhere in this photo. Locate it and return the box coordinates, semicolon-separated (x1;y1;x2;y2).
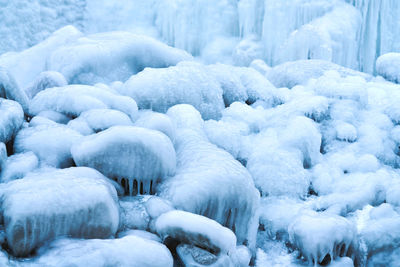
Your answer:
376;53;400;83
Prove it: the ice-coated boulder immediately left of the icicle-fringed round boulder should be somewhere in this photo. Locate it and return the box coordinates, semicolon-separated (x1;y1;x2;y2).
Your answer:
14;124;82;168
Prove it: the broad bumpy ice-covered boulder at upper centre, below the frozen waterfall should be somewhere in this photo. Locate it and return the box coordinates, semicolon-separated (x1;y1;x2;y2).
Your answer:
120;62;224;119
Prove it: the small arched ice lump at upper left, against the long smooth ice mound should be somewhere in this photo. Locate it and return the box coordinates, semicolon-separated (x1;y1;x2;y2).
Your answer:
25;71;68;98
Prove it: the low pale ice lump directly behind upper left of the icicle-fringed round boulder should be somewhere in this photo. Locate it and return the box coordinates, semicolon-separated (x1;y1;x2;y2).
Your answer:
67;109;133;135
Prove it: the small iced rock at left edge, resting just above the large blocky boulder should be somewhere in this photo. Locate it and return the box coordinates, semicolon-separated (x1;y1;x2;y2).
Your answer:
0;151;39;183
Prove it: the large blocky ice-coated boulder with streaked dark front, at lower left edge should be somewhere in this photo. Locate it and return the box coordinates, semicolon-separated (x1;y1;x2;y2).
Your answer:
1;168;119;256
